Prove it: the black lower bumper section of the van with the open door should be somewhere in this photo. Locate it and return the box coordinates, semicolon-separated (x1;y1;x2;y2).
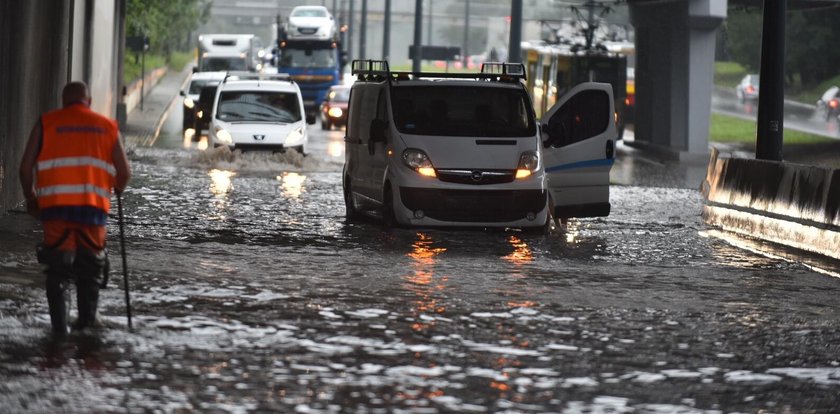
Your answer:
400;187;546;223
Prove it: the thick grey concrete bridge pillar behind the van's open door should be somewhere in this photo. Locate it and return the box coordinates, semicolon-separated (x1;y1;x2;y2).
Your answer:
629;0;727;159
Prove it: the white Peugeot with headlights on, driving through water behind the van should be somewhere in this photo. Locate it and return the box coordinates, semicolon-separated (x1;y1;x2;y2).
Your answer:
209;73;315;154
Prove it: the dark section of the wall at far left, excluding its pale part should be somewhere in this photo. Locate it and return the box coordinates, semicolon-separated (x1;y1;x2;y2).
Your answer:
0;0;72;215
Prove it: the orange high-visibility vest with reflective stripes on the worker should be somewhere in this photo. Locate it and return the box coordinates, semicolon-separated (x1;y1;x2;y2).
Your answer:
35;104;119;213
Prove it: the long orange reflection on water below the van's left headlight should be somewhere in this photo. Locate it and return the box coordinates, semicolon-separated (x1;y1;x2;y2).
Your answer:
405;232;449;331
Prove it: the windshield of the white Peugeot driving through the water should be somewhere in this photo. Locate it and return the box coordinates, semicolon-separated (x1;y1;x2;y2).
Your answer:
216;91;301;123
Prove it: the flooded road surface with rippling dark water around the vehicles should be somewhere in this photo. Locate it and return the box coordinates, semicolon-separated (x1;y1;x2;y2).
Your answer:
0;102;840;413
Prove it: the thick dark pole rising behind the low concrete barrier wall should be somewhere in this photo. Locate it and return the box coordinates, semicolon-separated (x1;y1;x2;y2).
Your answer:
755;0;787;161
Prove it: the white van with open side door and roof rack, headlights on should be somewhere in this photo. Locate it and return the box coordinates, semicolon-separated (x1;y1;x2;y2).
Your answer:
343;60;617;229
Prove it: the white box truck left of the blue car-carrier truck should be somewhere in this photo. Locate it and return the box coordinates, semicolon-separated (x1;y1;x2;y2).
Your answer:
196;34;262;72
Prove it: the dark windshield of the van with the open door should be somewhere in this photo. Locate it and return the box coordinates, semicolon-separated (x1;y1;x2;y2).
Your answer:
392;86;536;137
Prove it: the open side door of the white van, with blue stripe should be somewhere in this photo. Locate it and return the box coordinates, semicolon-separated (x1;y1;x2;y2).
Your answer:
540;82;617;218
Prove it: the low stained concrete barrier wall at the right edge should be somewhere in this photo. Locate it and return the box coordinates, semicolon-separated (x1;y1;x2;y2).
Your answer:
702;150;840;259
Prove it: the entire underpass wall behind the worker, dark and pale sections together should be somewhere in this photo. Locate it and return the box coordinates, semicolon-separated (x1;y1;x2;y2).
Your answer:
0;0;124;215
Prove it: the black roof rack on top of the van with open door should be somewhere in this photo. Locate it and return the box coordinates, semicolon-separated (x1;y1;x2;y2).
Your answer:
351;60;527;81
